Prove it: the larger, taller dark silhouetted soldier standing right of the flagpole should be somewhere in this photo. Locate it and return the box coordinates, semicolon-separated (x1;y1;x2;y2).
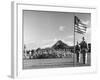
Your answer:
80;37;87;64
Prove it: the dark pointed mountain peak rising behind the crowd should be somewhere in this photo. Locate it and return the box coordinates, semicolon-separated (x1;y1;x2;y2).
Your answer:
52;40;69;50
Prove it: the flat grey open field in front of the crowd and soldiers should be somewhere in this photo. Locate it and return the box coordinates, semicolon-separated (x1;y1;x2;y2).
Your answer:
23;54;91;69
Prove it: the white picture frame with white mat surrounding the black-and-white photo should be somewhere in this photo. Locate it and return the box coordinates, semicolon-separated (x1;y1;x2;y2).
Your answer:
11;2;97;78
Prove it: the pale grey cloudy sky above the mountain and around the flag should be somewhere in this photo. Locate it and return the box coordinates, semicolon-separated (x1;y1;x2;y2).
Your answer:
23;10;91;49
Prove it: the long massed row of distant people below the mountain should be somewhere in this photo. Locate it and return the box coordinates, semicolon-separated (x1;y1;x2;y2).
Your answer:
24;48;72;59
